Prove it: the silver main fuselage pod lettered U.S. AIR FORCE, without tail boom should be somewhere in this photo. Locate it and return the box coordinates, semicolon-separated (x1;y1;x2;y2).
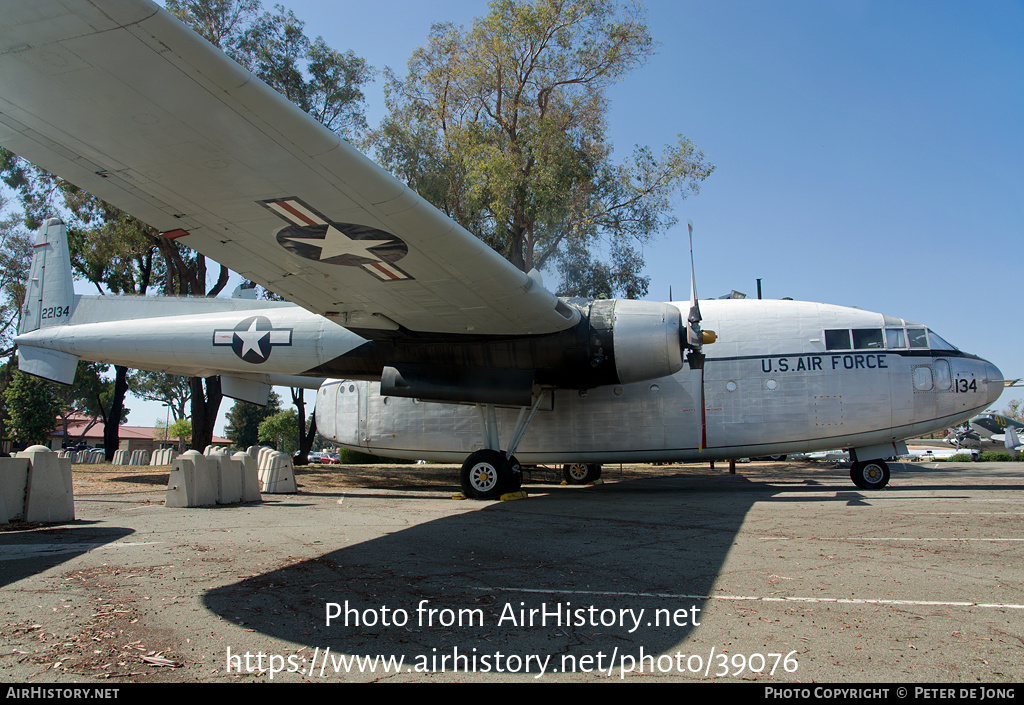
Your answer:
316;299;1002;464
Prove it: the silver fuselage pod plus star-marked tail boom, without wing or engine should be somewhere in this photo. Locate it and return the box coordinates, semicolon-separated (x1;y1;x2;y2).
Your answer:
17;286;1002;464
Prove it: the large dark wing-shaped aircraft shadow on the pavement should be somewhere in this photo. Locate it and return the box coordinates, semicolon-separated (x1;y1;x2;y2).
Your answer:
204;475;786;672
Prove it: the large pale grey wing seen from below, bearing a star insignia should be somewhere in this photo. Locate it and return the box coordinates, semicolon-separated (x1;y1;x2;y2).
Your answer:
0;0;579;336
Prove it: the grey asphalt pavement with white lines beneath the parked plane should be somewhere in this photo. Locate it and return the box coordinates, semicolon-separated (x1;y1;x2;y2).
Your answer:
0;462;1024;685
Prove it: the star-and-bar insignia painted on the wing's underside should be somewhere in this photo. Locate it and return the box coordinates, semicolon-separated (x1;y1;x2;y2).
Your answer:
258;197;412;282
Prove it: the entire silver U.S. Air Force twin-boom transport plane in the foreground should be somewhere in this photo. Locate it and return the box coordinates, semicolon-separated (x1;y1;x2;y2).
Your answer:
0;0;1002;497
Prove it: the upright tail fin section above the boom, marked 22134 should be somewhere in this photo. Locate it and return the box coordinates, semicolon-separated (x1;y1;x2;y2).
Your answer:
17;218;75;333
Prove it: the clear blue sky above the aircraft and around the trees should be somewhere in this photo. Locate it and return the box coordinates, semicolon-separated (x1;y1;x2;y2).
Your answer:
133;0;1024;432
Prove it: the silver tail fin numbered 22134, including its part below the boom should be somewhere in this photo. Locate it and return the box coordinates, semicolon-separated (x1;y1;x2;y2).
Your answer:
17;218;78;384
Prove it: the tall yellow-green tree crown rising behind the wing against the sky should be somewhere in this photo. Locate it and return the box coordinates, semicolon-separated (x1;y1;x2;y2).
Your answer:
371;0;714;297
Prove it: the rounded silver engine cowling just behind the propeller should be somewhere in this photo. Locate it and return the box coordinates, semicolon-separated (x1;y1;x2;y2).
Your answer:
590;299;684;384
